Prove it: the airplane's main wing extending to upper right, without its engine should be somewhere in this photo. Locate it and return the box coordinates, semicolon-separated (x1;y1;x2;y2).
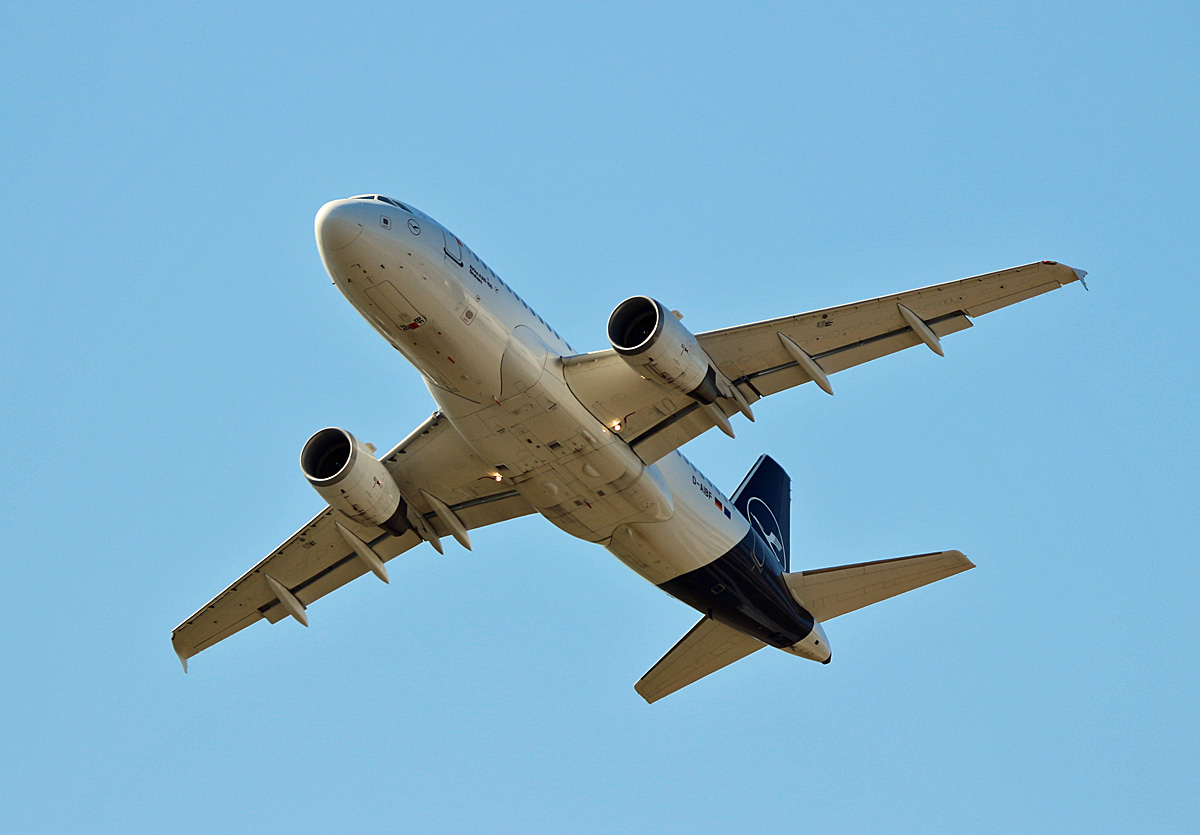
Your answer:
563;262;1087;463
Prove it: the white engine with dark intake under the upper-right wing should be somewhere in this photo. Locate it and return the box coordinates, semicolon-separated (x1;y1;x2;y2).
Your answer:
608;296;721;403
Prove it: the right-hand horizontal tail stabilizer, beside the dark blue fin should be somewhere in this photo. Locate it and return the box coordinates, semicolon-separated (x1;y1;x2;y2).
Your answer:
784;551;974;620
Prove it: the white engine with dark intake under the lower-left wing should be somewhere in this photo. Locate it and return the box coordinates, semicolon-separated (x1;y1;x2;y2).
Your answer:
300;426;409;534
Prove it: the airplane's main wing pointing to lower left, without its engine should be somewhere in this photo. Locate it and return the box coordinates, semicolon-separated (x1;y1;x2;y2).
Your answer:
170;413;534;671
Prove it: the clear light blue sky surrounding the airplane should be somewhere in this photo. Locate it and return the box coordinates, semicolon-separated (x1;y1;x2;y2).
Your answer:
0;2;1200;833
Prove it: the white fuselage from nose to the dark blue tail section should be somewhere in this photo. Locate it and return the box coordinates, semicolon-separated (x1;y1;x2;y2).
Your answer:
317;198;749;584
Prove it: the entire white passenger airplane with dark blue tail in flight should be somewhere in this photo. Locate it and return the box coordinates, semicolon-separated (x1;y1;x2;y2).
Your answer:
172;194;1087;702
